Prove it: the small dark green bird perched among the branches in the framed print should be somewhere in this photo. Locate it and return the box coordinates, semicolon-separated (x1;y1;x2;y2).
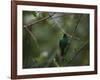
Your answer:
59;34;69;58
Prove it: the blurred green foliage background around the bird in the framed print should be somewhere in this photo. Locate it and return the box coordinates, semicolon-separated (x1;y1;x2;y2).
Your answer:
23;11;89;68
